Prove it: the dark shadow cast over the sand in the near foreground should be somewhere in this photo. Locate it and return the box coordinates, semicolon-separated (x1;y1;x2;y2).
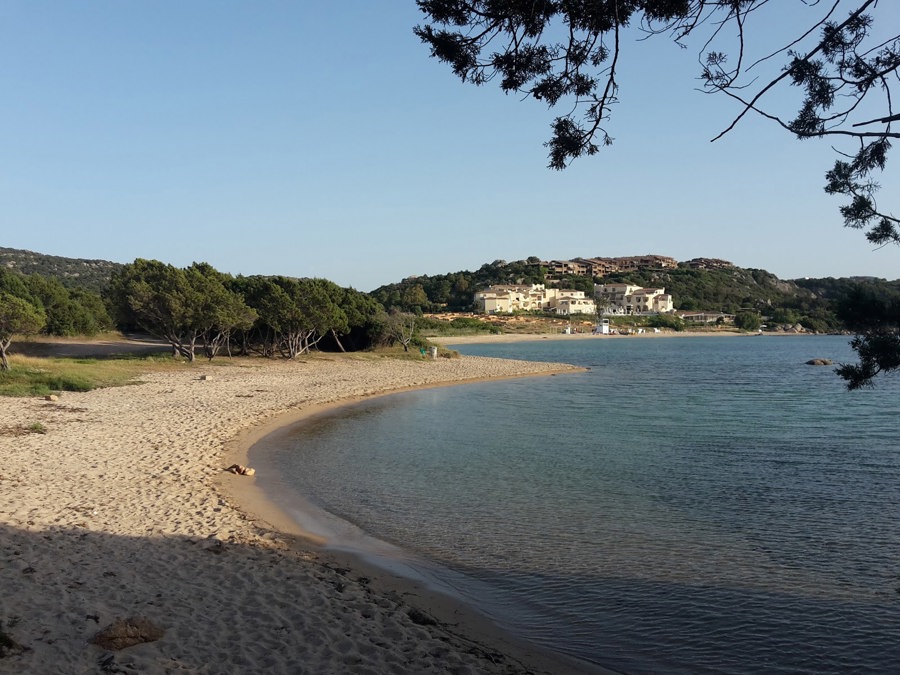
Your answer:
0;524;556;673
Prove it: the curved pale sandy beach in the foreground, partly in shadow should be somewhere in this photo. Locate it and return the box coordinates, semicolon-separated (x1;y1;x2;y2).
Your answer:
0;355;620;674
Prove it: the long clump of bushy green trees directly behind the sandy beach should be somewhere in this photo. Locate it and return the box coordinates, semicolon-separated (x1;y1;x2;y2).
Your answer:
109;259;383;360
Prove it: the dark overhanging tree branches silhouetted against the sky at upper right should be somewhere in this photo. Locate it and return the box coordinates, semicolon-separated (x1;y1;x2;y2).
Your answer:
414;0;900;243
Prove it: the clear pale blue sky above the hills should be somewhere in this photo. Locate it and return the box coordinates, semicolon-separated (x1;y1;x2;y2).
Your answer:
0;0;900;291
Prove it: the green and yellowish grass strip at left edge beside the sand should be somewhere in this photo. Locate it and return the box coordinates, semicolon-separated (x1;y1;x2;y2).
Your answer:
0;356;187;396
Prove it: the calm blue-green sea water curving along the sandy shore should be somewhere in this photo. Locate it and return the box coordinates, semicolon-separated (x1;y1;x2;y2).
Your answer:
254;337;900;673
